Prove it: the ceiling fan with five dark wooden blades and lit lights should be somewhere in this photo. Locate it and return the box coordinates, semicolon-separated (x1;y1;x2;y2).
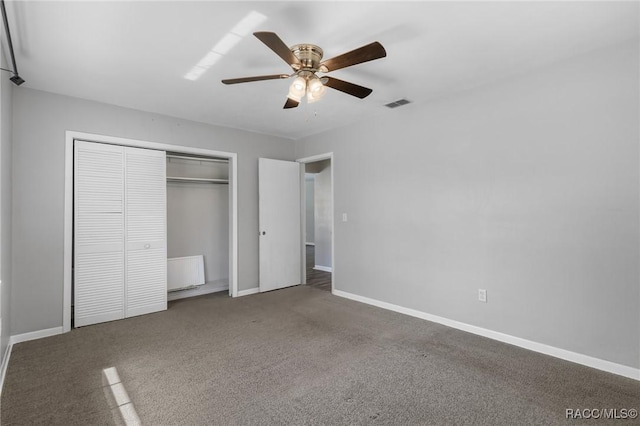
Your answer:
222;31;387;109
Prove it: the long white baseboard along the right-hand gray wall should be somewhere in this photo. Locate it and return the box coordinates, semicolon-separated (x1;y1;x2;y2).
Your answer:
333;290;640;381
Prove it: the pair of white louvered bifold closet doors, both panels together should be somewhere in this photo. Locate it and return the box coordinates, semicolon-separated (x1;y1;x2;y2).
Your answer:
74;141;167;327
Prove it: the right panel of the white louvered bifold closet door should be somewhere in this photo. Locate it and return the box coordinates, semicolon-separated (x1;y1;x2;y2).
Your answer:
125;148;167;317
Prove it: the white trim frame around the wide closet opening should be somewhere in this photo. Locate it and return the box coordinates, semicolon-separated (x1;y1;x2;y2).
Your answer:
62;130;238;333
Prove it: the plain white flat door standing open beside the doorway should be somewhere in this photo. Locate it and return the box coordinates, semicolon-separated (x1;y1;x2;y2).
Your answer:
258;158;302;291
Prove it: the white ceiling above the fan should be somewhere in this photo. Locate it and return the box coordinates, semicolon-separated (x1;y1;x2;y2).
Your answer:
7;1;638;139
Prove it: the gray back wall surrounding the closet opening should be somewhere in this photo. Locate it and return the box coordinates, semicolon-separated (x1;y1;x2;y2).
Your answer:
11;88;295;335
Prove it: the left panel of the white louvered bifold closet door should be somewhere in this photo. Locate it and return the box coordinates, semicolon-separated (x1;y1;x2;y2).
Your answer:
74;141;125;327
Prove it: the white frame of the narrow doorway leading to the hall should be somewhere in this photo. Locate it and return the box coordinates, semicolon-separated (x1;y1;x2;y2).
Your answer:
296;152;336;294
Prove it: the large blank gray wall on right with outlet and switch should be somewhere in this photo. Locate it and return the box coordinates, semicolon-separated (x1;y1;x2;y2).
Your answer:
296;40;640;368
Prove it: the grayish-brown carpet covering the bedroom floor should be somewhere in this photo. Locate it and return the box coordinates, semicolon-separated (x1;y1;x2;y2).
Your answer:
1;287;640;426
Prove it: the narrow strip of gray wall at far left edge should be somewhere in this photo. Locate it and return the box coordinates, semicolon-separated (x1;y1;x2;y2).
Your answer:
0;49;13;360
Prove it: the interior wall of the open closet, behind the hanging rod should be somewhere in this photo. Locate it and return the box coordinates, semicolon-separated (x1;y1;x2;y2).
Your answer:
167;153;230;300
